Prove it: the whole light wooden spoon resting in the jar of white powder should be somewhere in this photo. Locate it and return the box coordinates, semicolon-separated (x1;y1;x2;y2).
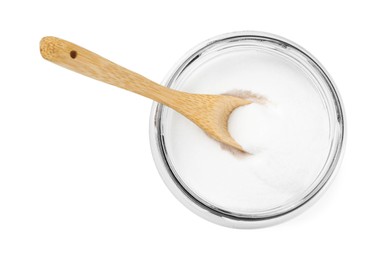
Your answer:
40;36;251;152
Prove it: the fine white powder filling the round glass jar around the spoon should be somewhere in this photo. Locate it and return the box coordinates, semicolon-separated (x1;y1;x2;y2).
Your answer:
165;50;330;215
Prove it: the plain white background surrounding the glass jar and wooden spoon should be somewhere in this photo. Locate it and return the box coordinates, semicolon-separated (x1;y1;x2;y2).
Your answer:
0;0;386;260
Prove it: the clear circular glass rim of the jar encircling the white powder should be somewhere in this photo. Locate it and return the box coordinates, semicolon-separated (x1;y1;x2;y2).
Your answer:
150;31;346;228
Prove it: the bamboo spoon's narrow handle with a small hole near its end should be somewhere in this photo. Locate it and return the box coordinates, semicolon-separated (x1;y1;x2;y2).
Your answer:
40;36;184;108
